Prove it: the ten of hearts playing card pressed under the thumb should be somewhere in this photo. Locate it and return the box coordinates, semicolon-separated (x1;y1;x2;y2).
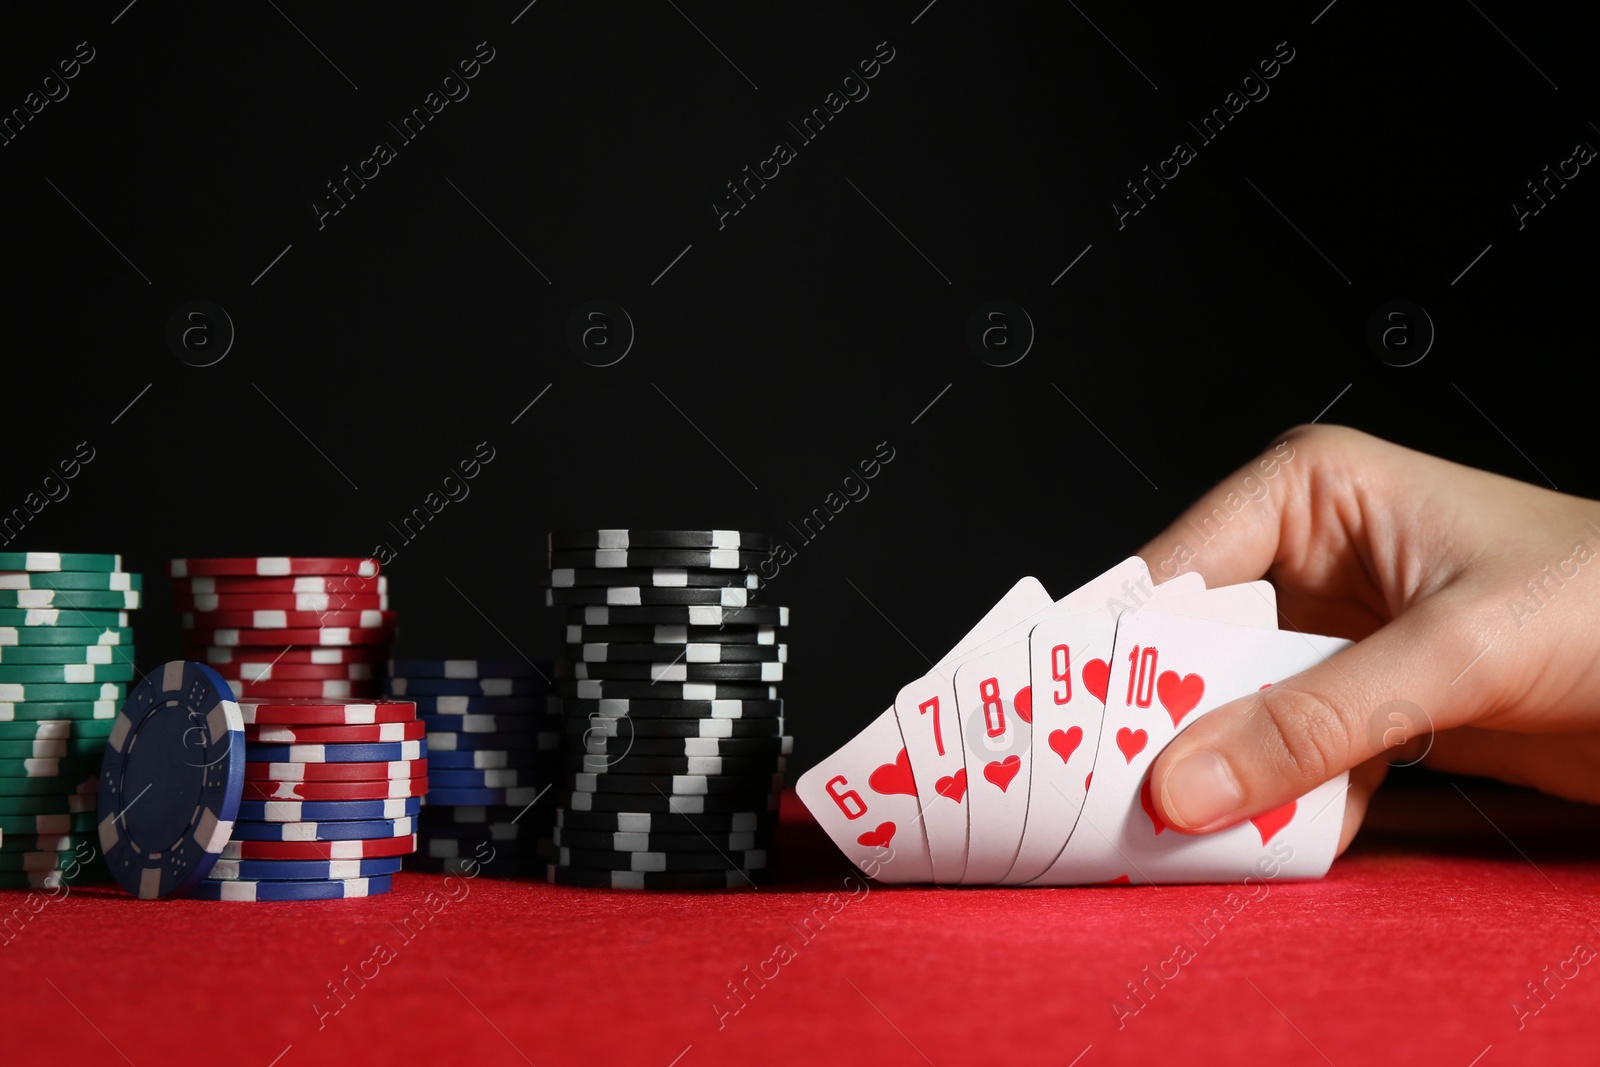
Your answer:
1034;611;1349;885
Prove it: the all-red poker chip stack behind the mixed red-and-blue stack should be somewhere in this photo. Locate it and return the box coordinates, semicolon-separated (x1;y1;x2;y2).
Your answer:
170;557;395;701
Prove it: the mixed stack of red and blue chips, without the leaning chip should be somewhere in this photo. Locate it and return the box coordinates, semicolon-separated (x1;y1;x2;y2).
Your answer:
192;697;429;901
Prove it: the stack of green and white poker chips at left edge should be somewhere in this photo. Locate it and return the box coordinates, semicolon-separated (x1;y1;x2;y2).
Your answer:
0;552;141;889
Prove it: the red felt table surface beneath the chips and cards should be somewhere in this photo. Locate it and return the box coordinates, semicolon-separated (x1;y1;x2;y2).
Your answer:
0;782;1600;1067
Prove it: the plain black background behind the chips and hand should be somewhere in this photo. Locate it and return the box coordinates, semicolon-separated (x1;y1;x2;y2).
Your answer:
0;0;1600;766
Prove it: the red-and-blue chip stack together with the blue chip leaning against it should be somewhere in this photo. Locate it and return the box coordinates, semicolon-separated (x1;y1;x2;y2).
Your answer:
98;659;427;901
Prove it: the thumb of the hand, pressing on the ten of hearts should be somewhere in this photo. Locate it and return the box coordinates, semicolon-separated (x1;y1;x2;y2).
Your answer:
1150;595;1482;833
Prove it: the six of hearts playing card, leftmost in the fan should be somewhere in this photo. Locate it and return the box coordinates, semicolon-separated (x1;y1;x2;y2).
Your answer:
795;707;933;883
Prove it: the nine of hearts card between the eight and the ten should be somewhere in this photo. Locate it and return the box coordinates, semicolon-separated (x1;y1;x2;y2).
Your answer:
1002;579;1277;885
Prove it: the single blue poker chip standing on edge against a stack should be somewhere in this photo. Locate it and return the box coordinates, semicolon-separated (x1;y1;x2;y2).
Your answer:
99;659;245;901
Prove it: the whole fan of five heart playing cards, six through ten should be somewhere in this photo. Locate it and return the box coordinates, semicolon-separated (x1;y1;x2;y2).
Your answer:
797;557;1349;886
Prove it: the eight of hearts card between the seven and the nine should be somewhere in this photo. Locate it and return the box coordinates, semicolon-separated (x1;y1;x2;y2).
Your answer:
923;557;1203;885
